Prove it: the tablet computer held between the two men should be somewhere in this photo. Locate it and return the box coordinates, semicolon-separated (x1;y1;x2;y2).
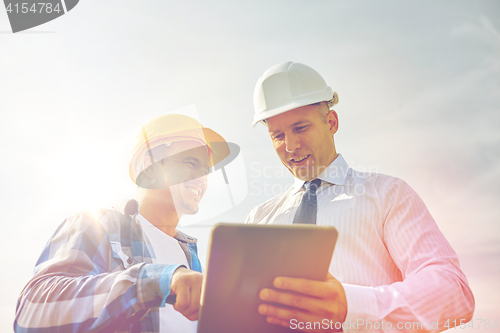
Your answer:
198;223;337;333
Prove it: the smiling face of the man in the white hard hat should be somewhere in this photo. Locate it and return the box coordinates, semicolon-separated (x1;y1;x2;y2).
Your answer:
267;104;338;181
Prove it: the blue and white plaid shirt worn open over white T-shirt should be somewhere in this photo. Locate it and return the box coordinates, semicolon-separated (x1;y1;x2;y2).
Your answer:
14;205;201;333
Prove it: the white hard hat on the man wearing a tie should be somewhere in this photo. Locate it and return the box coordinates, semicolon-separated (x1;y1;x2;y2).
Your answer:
252;61;339;126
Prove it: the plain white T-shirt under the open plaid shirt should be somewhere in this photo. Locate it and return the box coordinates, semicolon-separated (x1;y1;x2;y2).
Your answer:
136;214;198;333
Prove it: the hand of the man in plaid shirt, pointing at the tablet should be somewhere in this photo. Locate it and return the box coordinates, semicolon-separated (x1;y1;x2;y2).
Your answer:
170;267;203;320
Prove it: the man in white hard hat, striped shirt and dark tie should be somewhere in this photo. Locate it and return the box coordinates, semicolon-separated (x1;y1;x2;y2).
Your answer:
246;62;474;332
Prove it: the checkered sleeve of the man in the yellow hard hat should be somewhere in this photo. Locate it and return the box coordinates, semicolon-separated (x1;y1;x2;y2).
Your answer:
14;212;178;333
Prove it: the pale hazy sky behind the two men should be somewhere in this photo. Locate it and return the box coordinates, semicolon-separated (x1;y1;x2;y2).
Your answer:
0;0;500;332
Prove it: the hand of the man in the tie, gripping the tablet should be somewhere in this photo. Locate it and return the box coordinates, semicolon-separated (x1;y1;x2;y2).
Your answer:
258;274;347;333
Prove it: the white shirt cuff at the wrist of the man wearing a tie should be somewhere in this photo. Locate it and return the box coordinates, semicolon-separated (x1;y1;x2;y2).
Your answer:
342;284;378;332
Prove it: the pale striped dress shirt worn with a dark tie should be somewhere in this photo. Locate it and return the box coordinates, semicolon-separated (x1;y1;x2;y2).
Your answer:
246;155;474;332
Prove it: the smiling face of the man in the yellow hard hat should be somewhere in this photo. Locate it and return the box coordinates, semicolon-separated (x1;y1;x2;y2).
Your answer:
163;141;210;217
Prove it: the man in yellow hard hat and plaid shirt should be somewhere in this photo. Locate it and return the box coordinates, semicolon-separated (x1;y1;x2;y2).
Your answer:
14;114;229;333
